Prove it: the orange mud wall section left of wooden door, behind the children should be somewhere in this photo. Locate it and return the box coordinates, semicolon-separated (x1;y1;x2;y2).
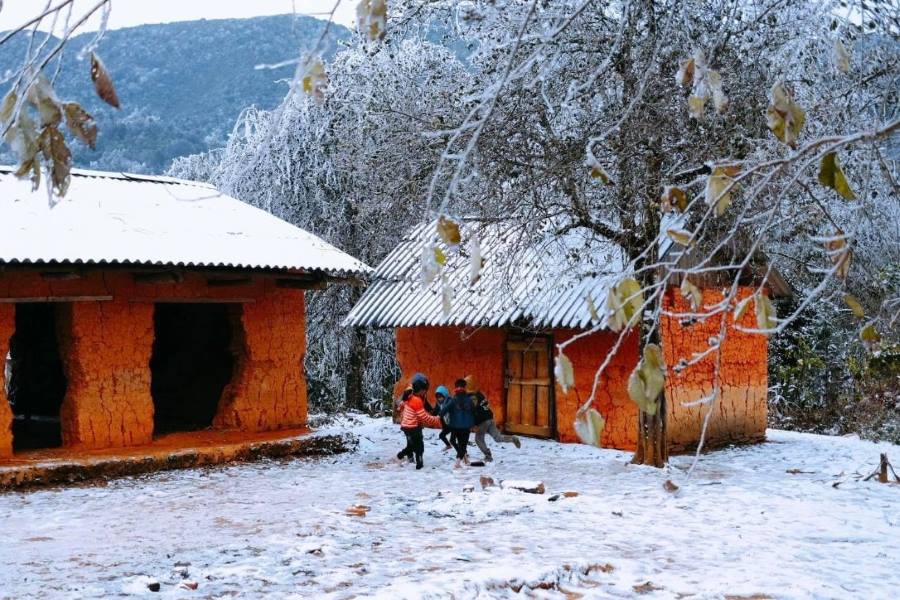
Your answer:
394;327;506;425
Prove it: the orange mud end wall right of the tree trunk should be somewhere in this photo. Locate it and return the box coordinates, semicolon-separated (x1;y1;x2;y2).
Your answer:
661;288;768;451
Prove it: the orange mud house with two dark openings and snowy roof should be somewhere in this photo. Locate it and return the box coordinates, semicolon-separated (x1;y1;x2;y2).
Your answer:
0;168;368;457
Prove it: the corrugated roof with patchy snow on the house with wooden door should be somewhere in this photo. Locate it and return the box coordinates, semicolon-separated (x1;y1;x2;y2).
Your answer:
345;220;625;329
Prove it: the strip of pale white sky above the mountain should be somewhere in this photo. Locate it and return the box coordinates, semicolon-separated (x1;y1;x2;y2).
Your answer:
0;0;357;31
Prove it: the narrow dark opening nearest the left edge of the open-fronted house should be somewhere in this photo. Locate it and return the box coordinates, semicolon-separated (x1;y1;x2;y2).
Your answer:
5;302;66;452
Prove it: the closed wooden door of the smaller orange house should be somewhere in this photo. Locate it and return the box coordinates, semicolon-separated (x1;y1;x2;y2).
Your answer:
504;336;554;438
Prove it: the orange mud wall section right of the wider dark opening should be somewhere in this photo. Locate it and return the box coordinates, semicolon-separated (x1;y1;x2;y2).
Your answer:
213;288;307;431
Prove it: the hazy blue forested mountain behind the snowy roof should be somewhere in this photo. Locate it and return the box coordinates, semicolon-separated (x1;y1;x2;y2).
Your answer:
0;15;350;173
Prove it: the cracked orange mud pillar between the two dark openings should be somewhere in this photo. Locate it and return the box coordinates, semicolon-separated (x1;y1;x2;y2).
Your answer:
57;299;153;448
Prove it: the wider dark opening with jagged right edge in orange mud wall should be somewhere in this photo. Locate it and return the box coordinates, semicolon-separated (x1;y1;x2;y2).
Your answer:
150;303;240;435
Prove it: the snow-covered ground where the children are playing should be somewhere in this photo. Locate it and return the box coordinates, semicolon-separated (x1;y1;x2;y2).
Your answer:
0;420;900;599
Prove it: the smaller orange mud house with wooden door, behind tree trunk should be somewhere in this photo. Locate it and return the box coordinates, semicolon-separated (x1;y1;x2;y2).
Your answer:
346;221;788;451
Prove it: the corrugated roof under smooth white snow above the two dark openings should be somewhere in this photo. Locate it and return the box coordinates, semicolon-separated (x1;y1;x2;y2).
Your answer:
0;167;371;277
